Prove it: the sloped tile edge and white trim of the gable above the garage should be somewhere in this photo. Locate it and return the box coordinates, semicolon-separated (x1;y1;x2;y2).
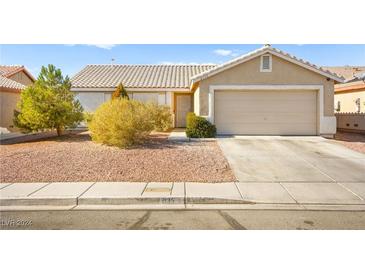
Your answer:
192;45;343;83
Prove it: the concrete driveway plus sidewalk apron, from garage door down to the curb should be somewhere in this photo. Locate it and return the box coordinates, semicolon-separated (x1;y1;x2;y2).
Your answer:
218;136;365;207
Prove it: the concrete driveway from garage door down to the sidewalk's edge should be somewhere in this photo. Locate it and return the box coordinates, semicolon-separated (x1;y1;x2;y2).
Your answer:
218;136;365;182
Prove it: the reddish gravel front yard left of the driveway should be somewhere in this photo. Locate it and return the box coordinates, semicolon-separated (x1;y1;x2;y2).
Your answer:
0;133;236;183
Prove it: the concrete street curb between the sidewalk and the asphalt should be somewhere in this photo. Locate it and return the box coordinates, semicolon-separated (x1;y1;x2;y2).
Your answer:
0;197;365;211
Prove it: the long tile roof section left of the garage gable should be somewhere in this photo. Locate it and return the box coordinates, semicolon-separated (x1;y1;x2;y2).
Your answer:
71;64;215;88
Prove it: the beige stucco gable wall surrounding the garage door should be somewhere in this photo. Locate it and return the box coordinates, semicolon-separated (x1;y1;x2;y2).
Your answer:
199;56;334;116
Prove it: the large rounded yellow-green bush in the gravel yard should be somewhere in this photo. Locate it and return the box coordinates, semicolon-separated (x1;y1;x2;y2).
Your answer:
89;98;154;148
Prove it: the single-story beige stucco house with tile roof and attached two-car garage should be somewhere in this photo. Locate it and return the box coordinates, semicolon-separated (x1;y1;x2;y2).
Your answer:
71;45;343;136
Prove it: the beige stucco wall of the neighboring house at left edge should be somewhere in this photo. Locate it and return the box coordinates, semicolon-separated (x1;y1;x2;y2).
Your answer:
0;91;20;130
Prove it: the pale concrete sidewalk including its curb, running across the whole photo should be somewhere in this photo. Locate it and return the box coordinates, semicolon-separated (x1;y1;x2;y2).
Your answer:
0;182;365;211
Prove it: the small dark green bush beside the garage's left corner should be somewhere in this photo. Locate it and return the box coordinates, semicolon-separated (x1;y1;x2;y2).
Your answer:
186;112;217;138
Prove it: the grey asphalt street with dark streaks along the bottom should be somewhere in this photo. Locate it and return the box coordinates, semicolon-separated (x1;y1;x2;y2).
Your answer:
0;210;365;230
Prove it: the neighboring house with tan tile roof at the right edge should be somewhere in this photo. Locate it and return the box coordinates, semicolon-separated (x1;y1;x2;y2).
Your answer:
327;66;365;113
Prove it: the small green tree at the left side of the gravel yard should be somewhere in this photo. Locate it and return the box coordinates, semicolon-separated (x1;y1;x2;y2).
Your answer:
14;65;83;136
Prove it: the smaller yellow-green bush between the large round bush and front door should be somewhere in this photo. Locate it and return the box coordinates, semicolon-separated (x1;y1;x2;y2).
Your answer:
146;102;172;131
